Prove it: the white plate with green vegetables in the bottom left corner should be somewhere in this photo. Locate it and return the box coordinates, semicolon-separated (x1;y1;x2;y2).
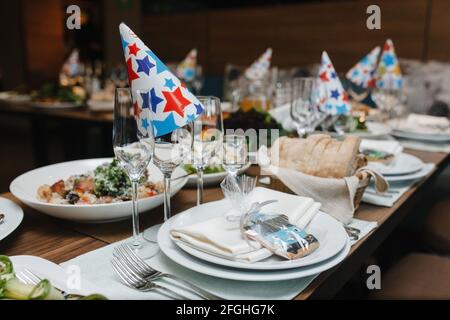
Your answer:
9;256;102;295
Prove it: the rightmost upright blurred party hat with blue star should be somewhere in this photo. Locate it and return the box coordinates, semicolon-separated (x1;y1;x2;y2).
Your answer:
376;39;403;90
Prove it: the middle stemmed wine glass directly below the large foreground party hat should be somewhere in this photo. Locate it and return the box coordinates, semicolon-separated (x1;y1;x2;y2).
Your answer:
143;125;192;242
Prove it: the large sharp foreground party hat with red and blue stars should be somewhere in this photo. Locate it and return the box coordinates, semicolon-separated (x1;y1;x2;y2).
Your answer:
119;23;204;137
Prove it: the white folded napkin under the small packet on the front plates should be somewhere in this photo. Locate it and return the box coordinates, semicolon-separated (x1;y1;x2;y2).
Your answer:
170;187;321;263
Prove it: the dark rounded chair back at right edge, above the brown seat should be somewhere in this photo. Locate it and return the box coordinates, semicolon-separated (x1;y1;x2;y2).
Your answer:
424;199;450;254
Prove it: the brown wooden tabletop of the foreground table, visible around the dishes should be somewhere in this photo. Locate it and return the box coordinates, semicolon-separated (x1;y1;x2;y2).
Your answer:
0;150;450;299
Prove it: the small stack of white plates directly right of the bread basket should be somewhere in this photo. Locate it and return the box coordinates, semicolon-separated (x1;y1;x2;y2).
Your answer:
367;153;429;182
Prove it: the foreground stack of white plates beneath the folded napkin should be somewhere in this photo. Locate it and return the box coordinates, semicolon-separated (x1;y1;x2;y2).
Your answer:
158;200;350;281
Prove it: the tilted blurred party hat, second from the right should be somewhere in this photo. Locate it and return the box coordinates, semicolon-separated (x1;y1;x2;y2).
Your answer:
346;47;380;88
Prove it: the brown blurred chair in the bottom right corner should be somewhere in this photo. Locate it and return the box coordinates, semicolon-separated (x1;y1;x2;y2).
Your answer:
370;253;450;300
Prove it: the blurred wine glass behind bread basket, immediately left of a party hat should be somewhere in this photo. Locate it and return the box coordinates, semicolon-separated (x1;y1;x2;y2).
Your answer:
291;77;316;137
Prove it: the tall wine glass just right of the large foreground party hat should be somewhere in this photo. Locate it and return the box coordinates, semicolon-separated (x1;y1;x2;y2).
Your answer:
191;96;223;205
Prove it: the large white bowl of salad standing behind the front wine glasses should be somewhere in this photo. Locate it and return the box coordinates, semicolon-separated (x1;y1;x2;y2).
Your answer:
9;158;188;222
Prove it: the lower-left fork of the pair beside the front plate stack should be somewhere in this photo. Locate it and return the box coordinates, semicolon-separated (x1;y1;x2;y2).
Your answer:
111;258;190;300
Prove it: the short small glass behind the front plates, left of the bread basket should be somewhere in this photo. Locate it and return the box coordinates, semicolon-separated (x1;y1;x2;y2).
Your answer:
222;134;248;177
